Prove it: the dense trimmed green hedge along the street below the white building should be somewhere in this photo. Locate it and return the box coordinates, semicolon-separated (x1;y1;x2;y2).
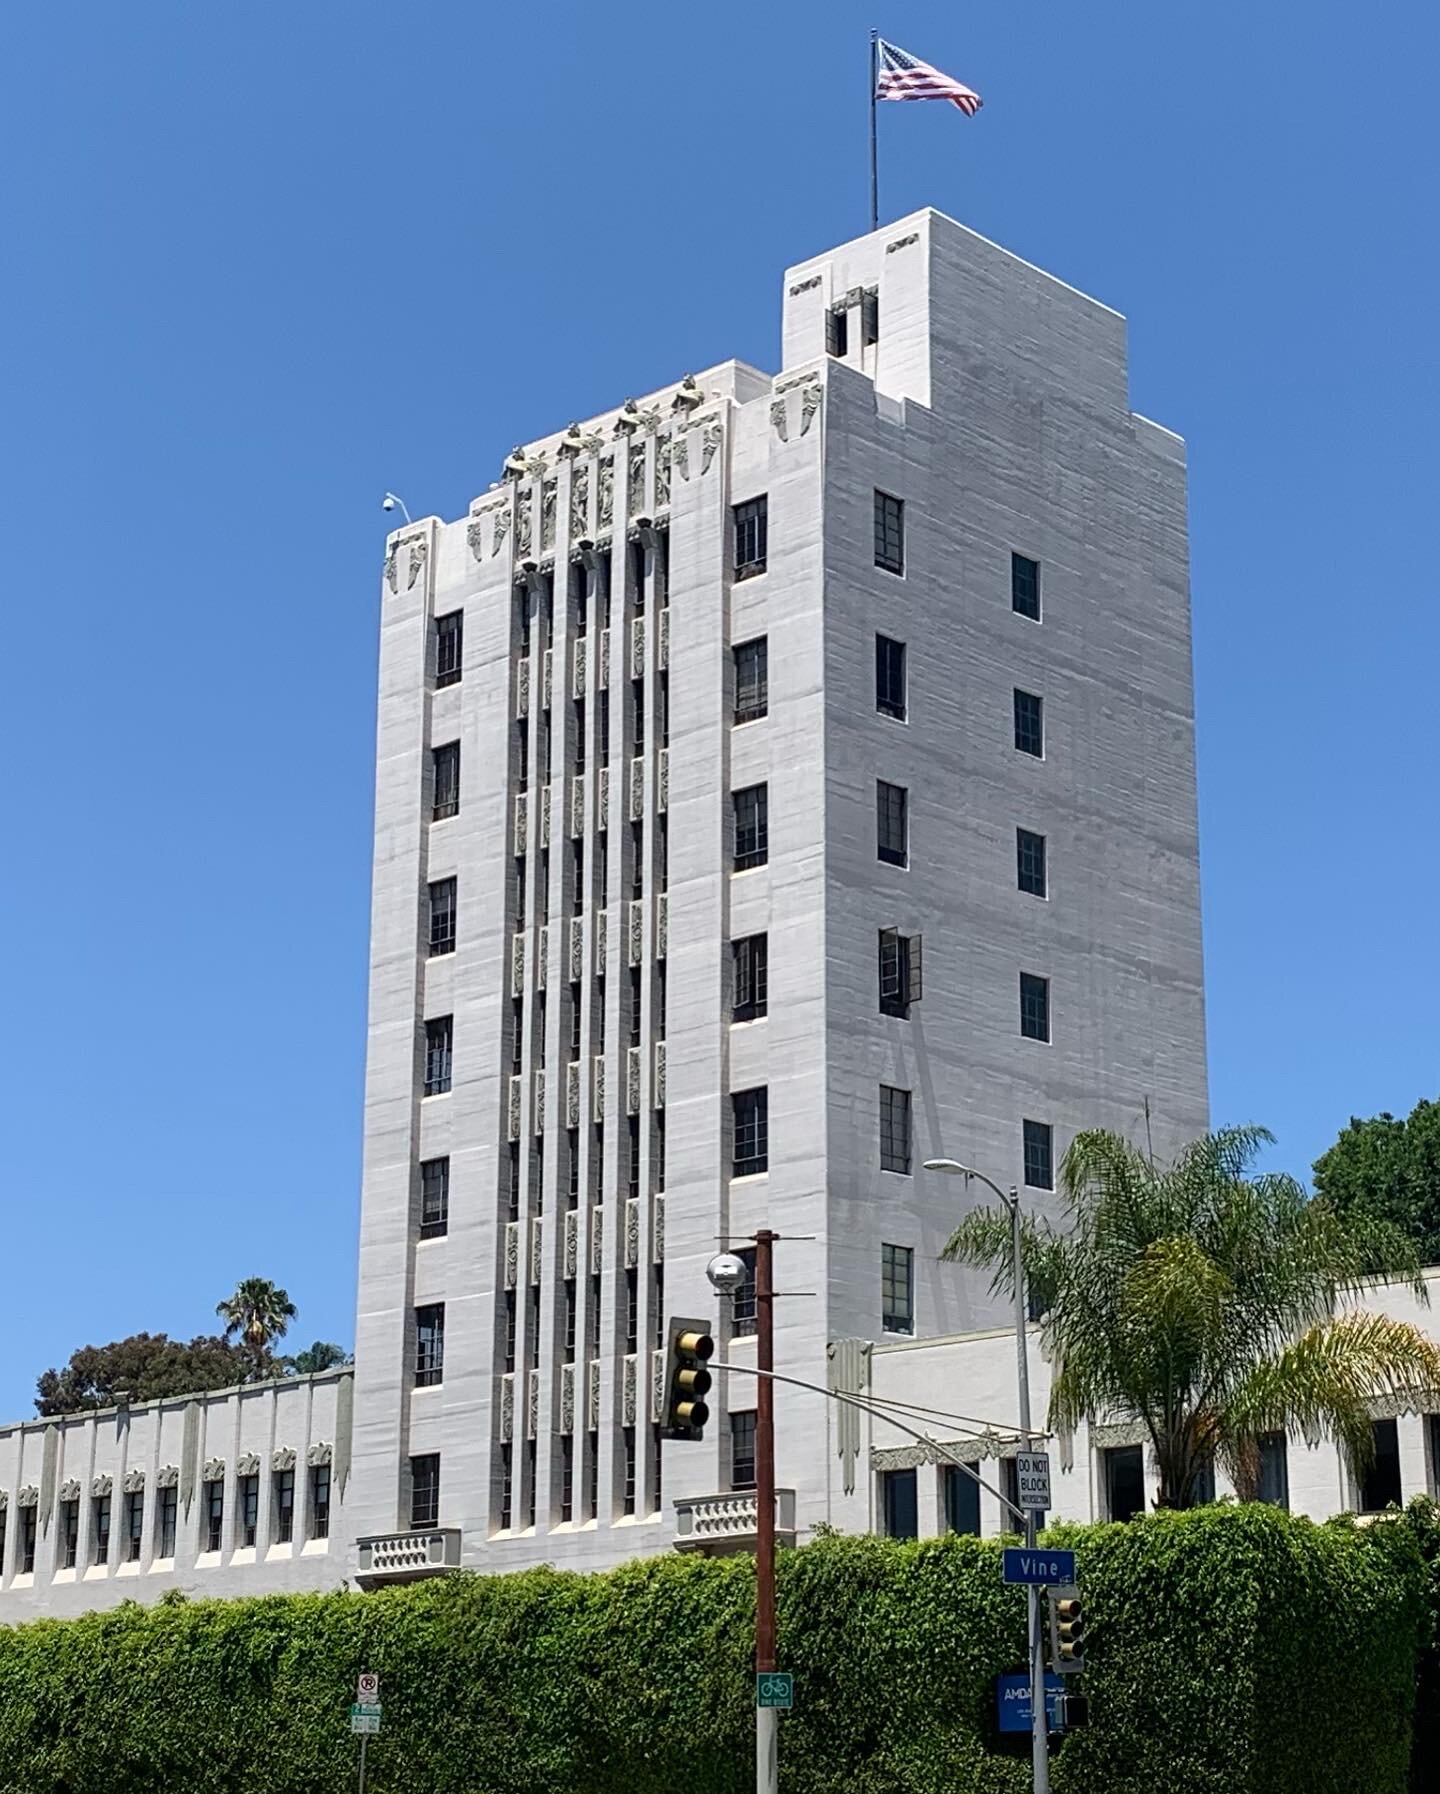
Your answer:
0;1507;1440;1794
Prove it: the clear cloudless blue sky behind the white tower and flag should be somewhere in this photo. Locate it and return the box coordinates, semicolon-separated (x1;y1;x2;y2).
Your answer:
0;0;1440;1417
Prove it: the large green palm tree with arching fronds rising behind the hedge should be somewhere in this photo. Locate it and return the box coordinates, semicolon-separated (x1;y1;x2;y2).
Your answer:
941;1127;1440;1507
